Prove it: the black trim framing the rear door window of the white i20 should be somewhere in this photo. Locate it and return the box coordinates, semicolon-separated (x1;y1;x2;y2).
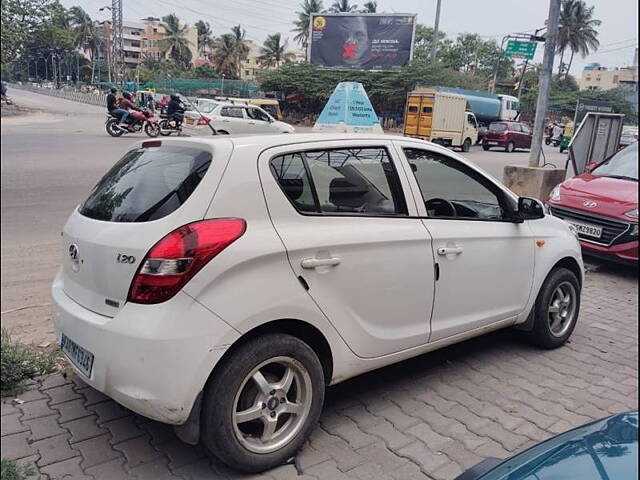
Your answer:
268;145;410;219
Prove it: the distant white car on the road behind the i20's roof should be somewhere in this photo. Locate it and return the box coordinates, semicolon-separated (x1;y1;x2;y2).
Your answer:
183;99;295;135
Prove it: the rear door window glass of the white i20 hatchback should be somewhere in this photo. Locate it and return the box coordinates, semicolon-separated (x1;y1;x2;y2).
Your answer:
271;147;407;216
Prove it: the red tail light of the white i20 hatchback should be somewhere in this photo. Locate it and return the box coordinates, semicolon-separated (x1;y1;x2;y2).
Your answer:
129;218;247;304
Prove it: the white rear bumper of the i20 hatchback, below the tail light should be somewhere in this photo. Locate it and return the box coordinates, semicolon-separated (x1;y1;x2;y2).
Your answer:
51;274;239;425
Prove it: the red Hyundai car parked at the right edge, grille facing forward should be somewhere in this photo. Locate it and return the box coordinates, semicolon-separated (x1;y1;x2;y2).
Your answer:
547;142;638;263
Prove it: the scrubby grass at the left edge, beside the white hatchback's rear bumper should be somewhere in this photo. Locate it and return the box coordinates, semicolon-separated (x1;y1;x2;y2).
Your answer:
0;328;58;396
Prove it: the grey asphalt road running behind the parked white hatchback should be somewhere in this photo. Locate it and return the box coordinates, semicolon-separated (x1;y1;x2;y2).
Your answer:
0;89;566;344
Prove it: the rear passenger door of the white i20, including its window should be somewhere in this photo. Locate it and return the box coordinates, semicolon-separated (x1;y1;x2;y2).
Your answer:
259;140;435;358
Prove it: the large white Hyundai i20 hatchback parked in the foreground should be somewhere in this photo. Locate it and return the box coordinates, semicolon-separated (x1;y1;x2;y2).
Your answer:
52;134;583;471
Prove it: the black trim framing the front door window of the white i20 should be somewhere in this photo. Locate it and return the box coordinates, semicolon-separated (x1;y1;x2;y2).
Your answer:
399;144;517;223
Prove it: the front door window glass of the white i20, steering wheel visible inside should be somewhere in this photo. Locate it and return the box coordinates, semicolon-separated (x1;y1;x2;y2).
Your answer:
404;148;507;221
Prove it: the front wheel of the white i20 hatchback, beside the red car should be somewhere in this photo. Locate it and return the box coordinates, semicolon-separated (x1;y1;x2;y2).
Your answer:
529;268;580;349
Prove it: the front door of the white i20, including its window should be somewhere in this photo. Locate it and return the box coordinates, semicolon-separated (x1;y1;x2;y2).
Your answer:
397;142;535;341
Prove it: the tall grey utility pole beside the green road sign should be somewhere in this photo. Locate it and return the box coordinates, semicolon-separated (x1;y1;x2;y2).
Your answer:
529;0;561;167
